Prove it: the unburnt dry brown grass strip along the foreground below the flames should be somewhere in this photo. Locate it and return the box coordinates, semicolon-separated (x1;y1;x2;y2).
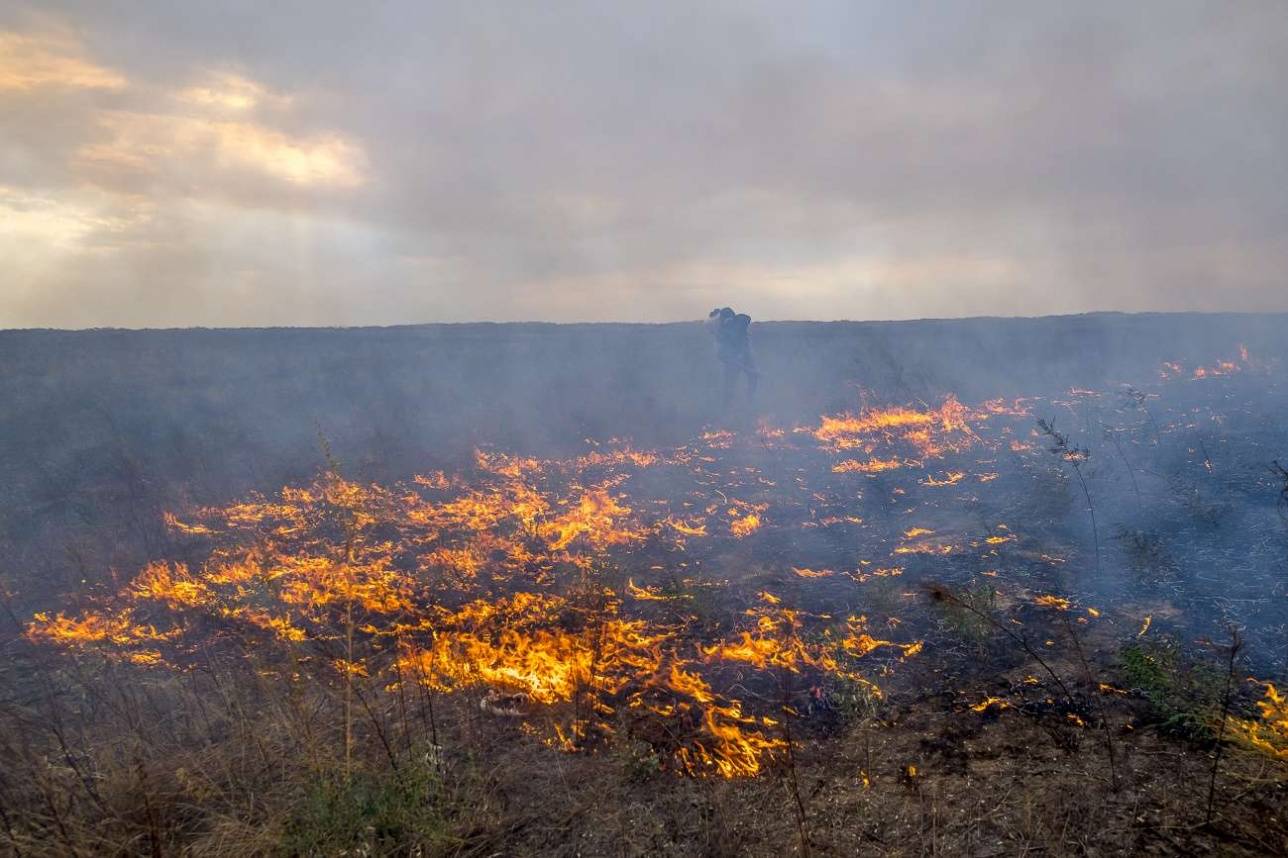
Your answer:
0;615;1288;857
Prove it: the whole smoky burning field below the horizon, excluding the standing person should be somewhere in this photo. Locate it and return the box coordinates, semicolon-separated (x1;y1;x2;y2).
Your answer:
0;316;1288;855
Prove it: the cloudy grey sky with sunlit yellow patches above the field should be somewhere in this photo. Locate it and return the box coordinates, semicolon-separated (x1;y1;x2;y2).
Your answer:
0;0;1288;327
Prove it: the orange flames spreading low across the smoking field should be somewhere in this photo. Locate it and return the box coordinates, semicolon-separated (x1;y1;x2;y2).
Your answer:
26;356;1257;777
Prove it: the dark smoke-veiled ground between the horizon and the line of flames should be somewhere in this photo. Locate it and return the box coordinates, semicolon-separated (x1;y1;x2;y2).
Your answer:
0;314;1288;605
